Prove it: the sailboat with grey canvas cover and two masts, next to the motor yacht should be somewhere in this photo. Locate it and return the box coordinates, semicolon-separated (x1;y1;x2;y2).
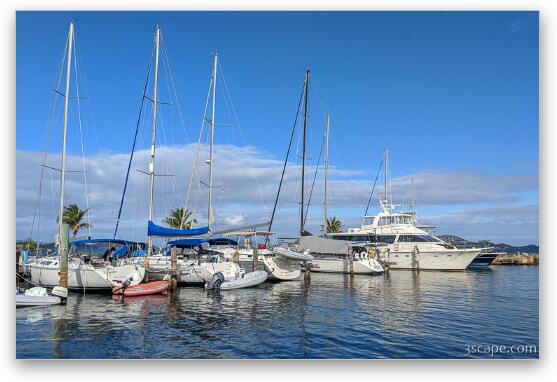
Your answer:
275;70;384;274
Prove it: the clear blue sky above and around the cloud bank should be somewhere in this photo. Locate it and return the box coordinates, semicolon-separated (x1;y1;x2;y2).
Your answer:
16;12;539;243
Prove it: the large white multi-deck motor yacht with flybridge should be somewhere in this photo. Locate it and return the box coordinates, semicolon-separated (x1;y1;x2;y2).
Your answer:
329;150;482;271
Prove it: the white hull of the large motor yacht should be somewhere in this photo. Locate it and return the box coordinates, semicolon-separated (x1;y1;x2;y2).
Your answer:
381;249;481;271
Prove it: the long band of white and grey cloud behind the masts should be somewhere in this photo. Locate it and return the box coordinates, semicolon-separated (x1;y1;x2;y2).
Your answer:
16;145;537;240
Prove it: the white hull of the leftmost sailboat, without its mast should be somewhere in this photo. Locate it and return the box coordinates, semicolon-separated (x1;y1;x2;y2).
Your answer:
29;258;145;290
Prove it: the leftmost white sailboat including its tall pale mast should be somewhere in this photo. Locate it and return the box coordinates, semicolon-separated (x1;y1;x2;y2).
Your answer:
29;22;145;294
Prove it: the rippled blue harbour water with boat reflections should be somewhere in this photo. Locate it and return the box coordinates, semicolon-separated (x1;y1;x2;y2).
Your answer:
16;266;540;358
